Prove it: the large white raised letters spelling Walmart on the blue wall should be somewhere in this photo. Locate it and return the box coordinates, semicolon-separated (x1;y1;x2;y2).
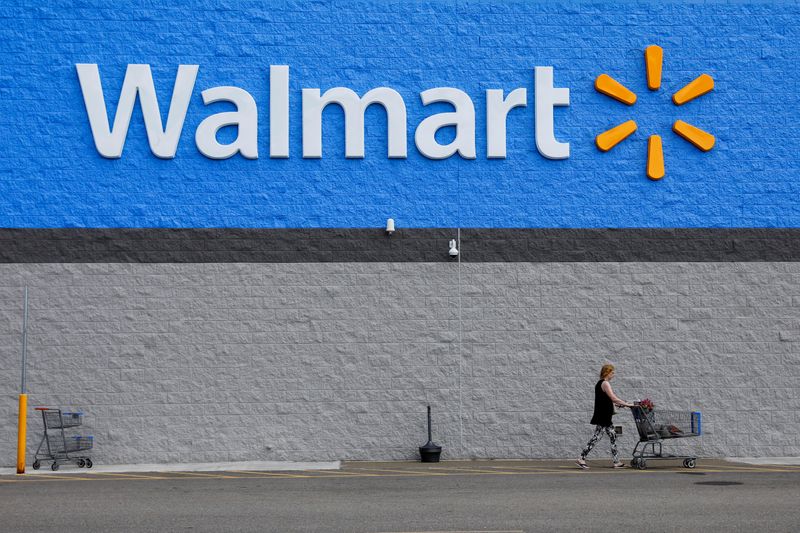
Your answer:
77;64;569;159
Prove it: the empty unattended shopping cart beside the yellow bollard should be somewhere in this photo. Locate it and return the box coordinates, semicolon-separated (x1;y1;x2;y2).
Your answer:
33;407;94;470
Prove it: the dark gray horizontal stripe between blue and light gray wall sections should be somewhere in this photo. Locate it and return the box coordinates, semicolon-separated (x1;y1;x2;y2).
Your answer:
0;228;800;263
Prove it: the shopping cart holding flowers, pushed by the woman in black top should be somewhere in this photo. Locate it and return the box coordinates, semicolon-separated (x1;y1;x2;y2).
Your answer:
631;404;702;470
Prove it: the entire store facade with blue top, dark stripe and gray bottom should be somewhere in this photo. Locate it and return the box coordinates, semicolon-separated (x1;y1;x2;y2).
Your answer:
0;1;800;464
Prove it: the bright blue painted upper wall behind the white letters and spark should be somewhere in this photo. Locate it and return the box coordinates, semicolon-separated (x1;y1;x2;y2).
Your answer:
0;0;800;228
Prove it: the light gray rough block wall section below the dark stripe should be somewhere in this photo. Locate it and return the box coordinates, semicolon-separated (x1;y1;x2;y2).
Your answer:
0;263;800;466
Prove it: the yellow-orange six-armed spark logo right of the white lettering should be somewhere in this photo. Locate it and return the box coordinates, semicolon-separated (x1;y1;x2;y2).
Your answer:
594;45;715;180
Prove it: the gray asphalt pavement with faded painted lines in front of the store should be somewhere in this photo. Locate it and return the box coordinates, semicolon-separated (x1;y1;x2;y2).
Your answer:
0;459;800;533
